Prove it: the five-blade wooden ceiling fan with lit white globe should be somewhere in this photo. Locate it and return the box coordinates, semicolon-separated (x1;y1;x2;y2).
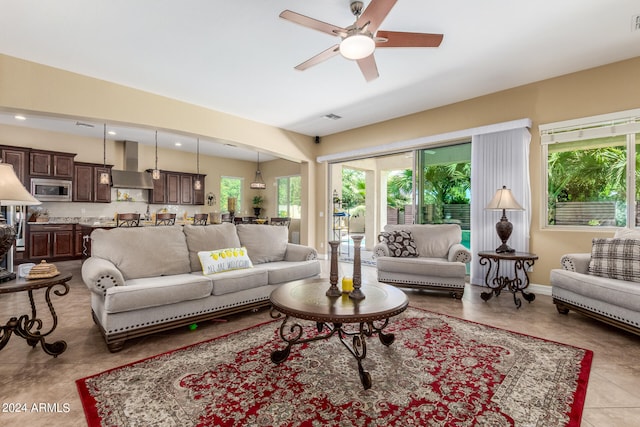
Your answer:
280;0;443;81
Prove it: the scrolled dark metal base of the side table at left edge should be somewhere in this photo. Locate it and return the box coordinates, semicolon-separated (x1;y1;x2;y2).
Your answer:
0;275;71;357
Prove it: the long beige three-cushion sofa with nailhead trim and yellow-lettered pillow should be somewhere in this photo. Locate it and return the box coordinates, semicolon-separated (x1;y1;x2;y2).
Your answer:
82;223;320;352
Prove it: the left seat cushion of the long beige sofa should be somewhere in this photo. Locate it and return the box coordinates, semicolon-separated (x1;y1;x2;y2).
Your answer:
104;274;213;313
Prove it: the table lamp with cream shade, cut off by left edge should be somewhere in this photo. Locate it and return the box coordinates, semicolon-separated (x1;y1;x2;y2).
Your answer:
0;162;40;283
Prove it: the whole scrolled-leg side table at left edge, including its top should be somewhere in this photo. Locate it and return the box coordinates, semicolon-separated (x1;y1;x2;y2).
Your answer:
0;273;72;357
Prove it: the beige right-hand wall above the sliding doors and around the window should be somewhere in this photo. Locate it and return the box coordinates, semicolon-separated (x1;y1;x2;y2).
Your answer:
316;58;640;284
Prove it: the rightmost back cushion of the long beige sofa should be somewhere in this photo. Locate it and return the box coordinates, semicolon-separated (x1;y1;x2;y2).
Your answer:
236;224;289;264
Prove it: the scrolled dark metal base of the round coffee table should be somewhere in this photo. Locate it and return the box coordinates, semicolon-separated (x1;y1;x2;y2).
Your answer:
271;310;395;390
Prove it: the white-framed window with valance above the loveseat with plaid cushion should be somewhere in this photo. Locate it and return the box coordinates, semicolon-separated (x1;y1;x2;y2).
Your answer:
540;110;640;231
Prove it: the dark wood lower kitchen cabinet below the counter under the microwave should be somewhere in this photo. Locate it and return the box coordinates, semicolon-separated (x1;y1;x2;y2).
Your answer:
27;224;75;261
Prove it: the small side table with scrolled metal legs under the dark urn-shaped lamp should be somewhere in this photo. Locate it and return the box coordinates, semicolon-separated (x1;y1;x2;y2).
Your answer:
478;251;538;308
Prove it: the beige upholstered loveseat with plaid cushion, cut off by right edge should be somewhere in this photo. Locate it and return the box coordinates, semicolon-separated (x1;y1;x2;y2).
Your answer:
550;230;640;335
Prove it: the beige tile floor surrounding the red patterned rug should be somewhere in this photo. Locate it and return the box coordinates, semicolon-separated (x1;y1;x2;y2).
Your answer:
0;261;640;427
